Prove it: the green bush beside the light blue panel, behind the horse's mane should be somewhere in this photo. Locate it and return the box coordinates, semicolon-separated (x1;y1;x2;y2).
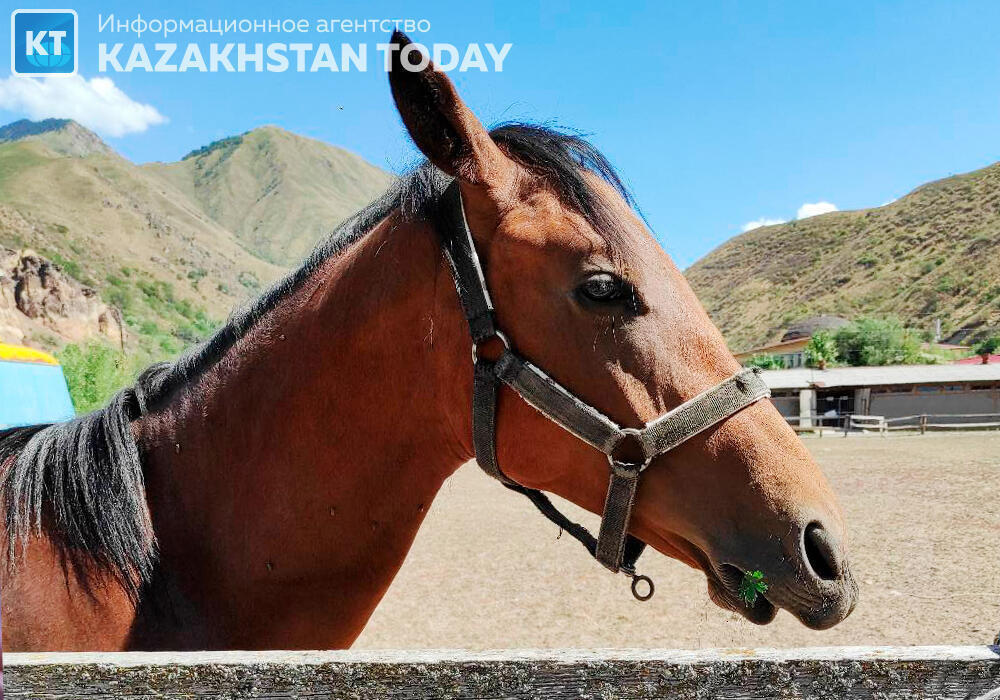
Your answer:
58;340;140;413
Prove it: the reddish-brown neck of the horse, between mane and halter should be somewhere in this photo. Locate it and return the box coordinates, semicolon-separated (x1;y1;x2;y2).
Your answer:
140;211;471;648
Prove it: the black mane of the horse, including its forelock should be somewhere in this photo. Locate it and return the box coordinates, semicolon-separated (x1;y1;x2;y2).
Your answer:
0;123;633;600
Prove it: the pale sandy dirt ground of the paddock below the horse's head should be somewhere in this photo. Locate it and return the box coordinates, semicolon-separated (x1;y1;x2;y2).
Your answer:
356;432;1000;649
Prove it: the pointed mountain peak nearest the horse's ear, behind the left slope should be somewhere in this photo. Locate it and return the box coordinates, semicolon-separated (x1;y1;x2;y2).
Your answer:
144;126;391;265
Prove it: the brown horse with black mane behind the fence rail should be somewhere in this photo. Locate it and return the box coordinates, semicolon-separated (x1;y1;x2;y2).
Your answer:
0;36;857;650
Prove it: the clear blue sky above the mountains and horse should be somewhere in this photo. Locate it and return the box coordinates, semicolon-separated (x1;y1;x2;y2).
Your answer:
0;0;1000;267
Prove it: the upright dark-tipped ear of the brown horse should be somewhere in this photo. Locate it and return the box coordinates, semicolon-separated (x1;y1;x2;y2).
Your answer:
389;30;513;187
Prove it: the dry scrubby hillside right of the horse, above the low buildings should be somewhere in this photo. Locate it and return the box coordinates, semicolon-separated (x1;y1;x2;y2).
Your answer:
685;163;1000;350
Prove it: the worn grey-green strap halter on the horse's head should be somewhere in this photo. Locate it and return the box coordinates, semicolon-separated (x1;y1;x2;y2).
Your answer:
441;180;771;600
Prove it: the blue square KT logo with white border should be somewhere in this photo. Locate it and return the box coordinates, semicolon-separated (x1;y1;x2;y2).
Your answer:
10;10;78;77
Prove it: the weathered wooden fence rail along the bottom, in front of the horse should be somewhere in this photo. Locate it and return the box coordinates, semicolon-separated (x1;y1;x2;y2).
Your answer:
5;646;1000;700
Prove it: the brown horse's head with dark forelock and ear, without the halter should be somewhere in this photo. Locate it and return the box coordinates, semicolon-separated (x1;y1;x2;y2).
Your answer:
390;34;857;629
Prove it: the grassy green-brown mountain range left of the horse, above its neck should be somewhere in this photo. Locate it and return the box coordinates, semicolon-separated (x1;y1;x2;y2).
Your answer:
0;119;389;358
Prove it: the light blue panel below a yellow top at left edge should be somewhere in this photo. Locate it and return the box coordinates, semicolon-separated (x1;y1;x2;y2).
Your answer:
0;360;76;430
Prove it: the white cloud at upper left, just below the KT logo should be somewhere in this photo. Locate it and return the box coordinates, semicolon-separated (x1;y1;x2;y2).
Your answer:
0;75;167;136
